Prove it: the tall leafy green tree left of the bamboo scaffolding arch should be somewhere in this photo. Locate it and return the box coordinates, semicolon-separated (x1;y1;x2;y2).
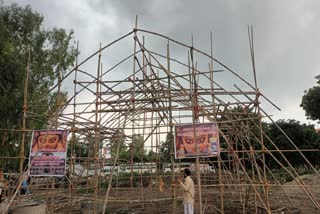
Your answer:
0;4;78;171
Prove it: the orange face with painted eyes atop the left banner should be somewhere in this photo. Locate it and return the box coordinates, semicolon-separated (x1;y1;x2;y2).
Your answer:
32;133;66;152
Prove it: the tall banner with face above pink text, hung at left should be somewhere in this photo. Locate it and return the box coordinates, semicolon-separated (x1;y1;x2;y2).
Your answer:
29;130;69;176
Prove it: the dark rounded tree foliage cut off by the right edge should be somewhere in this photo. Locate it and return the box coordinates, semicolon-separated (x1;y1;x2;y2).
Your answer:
300;75;320;120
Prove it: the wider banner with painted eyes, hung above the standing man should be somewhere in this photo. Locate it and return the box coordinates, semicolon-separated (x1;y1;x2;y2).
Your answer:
174;123;220;159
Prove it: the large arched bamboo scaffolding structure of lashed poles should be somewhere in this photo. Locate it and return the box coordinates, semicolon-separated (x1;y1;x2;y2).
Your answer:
0;25;320;213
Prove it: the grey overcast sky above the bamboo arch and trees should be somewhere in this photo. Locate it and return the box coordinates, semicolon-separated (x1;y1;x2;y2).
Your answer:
4;0;320;126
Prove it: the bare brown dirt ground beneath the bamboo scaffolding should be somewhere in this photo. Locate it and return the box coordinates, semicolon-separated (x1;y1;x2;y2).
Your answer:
1;174;320;214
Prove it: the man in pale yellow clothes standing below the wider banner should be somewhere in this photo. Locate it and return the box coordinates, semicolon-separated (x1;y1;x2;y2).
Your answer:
178;168;194;214
